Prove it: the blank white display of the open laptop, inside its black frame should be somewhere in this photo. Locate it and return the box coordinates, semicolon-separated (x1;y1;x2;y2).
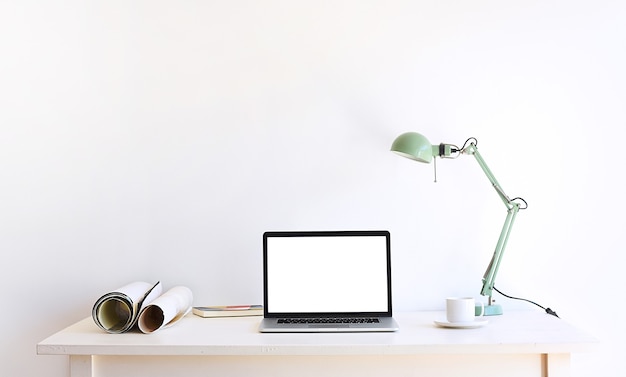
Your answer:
267;236;388;313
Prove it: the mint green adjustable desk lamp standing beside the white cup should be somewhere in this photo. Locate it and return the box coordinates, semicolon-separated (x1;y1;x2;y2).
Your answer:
391;132;528;315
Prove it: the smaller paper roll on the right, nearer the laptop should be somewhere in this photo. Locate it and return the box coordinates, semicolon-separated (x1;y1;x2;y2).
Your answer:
137;286;193;333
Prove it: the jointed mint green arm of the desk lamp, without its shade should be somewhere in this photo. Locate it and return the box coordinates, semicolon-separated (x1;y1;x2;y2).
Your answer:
462;143;520;305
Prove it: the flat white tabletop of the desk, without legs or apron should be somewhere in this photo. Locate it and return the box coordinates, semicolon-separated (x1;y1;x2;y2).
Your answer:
37;311;597;356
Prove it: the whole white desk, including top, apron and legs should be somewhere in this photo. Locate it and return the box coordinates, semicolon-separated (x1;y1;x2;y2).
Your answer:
37;311;596;377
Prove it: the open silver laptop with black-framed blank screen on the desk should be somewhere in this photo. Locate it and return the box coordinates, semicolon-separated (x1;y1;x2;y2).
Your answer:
259;231;398;332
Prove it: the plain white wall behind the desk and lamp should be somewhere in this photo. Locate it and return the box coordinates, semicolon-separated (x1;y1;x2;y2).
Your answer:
0;0;626;376
